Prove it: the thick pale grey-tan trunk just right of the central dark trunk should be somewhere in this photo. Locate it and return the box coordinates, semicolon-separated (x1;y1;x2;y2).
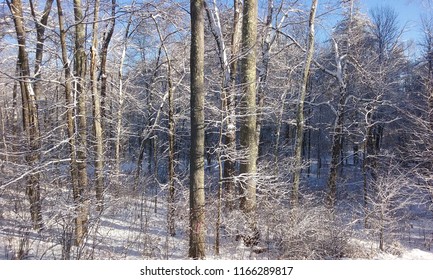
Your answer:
240;0;258;234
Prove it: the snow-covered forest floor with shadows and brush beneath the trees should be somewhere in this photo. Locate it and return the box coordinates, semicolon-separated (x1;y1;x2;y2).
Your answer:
0;164;433;260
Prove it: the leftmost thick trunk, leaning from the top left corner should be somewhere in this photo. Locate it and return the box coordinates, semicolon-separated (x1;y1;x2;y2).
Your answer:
7;0;43;230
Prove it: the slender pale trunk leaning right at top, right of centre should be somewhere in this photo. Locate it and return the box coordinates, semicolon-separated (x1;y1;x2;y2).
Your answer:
291;0;318;207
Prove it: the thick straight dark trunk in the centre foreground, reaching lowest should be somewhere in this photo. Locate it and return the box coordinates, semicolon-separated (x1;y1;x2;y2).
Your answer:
188;0;205;259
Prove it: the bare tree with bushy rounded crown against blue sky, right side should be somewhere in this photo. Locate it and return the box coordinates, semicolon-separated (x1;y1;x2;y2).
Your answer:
362;6;403;217
